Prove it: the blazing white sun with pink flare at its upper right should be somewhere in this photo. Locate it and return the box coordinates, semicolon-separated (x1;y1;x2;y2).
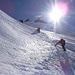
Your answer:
49;2;68;22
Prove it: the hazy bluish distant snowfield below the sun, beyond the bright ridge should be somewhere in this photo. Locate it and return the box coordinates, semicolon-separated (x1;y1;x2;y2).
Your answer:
24;21;75;37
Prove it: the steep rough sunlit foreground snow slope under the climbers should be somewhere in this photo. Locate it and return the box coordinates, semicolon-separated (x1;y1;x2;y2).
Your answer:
0;10;75;75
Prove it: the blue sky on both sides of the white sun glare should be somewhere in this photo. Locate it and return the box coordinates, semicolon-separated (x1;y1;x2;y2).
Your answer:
0;0;75;30
